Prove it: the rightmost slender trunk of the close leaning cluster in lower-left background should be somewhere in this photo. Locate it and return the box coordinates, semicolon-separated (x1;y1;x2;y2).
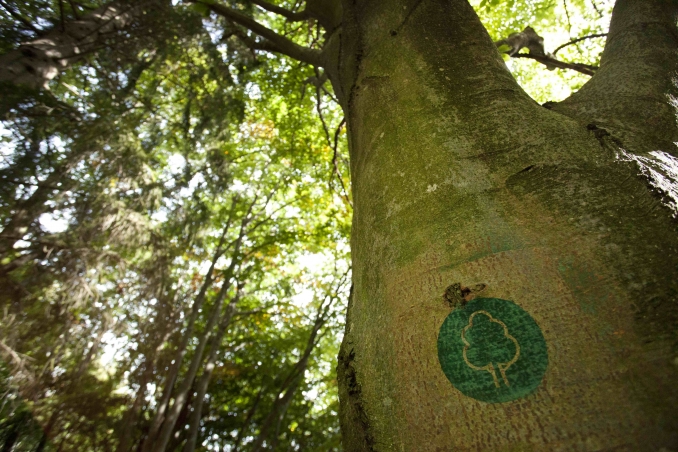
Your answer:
183;294;240;452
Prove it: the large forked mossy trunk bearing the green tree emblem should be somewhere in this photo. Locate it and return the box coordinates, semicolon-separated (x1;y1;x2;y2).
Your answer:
334;0;678;451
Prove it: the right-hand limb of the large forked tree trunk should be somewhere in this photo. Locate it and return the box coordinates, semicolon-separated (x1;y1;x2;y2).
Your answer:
554;0;678;156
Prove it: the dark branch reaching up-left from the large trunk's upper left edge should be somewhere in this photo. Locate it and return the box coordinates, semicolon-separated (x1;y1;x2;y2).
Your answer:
193;0;323;67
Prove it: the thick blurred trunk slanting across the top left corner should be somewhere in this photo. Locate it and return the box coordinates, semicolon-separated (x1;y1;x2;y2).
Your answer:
0;1;143;88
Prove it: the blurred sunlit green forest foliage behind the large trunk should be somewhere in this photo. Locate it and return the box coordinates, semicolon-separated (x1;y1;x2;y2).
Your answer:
0;0;612;452
